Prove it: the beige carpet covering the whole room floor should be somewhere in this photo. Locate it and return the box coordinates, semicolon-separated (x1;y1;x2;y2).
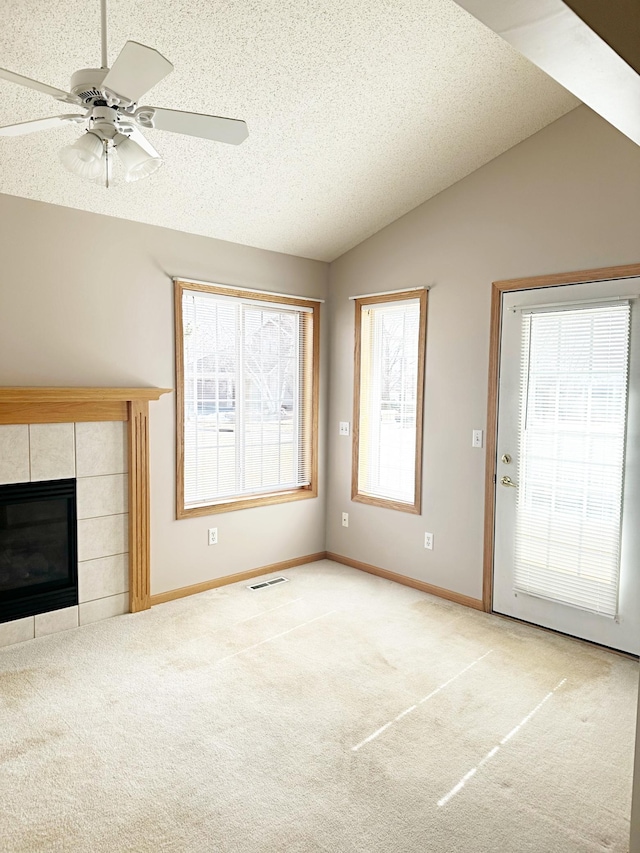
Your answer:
0;561;638;853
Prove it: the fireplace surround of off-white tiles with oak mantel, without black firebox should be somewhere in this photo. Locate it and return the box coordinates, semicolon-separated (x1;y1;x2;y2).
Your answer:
0;388;170;646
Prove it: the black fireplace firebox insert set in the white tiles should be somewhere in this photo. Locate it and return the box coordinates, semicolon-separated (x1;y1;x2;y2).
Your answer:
0;479;78;622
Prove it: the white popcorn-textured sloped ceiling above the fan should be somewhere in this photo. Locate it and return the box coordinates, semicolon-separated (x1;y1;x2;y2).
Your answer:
0;0;578;260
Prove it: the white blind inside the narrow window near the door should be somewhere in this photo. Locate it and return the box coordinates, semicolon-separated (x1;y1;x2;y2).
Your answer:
358;299;420;504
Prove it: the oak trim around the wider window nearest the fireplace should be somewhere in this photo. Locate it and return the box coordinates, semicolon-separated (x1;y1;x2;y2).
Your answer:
174;280;320;520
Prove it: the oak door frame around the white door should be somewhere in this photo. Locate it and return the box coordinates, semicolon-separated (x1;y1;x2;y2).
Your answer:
482;264;640;613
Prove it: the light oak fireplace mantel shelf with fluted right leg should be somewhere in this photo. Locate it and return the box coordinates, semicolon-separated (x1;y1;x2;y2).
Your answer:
0;387;172;613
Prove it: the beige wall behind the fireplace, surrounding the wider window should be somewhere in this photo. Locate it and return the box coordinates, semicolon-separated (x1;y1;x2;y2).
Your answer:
0;198;327;593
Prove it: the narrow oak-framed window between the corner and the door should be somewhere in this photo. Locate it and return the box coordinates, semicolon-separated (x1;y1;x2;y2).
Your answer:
351;290;427;514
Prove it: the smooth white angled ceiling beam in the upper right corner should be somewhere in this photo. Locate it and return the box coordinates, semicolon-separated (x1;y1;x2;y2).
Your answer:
456;0;640;145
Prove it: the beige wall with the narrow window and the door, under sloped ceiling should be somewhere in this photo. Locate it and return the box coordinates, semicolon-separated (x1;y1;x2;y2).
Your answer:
327;107;640;598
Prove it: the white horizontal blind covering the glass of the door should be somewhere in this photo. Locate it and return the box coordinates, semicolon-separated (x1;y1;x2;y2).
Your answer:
514;302;630;617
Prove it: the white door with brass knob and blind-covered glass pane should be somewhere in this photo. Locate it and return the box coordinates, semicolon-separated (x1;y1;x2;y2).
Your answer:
493;278;640;654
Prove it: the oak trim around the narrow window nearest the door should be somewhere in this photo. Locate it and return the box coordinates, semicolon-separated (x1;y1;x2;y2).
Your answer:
351;289;428;515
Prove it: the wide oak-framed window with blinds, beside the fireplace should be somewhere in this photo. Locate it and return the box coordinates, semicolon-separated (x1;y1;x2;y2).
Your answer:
176;281;319;518
